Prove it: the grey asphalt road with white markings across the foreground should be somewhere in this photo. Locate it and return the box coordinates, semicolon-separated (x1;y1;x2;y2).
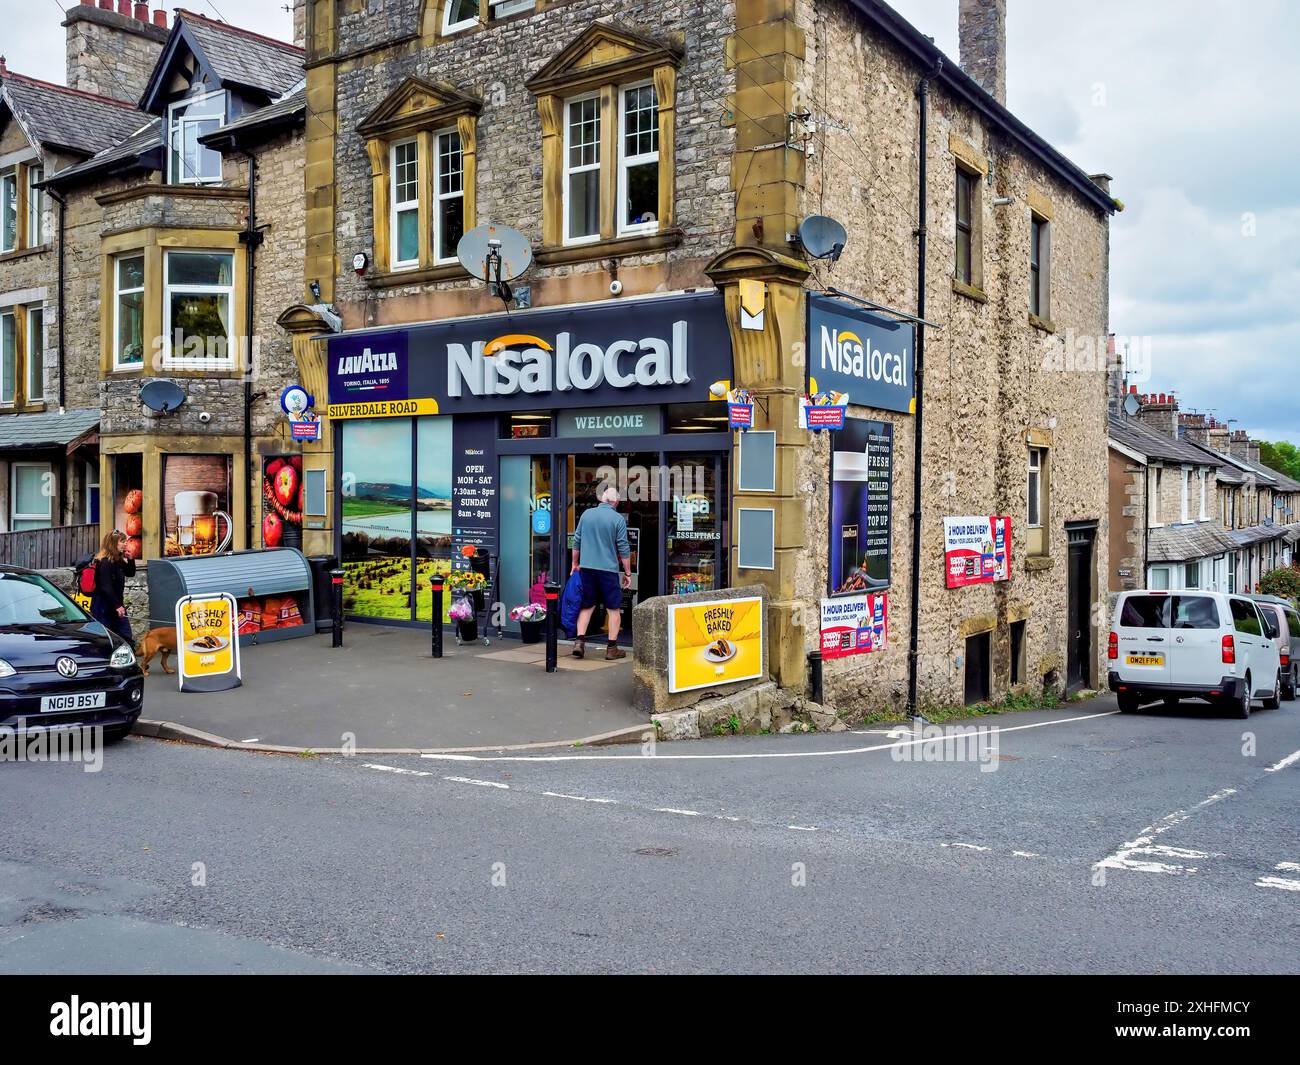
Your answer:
0;701;1300;973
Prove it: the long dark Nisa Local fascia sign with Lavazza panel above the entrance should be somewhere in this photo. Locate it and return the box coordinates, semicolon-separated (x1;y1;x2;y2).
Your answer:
329;293;732;417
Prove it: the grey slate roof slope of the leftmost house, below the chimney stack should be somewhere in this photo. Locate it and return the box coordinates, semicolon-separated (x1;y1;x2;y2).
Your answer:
0;74;150;156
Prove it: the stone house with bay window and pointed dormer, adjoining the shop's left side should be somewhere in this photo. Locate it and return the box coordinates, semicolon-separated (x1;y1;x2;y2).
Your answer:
48;4;306;559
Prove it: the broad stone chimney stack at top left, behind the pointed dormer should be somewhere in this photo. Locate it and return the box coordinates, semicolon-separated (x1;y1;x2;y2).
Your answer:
64;0;168;107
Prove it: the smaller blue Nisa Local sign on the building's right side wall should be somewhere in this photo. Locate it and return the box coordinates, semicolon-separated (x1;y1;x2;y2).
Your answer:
807;293;917;414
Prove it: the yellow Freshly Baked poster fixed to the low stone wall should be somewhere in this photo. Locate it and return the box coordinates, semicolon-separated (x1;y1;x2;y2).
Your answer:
668;598;763;692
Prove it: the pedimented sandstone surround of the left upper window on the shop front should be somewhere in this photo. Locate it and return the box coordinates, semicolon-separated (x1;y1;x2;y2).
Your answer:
356;78;482;287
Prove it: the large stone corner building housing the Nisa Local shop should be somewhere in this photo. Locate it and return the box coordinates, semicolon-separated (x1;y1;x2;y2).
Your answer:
297;0;1117;719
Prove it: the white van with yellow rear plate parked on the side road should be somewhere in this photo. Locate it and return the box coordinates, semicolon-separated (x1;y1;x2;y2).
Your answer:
1106;590;1282;718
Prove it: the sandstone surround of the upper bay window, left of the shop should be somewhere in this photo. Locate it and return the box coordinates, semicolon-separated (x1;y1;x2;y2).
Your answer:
99;226;248;378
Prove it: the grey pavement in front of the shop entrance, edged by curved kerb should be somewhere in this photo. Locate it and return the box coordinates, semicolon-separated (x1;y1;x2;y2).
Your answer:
139;624;647;752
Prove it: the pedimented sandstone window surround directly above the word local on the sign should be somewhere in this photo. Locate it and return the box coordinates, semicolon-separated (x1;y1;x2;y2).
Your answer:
527;22;683;265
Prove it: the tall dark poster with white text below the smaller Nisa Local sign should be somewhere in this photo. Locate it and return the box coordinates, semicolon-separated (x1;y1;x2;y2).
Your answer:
829;417;893;596
